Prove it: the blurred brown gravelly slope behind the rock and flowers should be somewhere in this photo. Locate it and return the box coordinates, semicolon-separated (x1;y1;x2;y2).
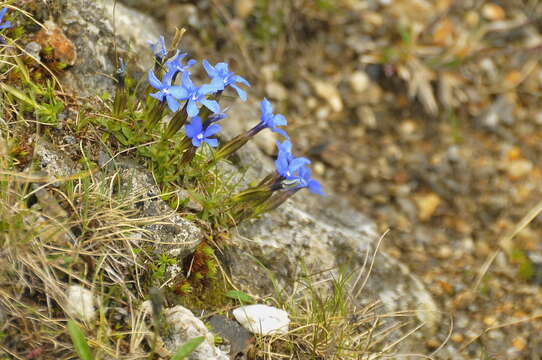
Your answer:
122;0;542;359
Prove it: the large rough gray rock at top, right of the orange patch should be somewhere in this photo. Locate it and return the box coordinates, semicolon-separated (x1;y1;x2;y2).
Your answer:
57;0;160;96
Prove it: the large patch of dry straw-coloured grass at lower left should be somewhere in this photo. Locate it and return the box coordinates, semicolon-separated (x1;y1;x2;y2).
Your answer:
0;142;162;359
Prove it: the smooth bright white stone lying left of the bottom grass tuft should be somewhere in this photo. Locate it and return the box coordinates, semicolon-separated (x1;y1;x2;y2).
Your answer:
233;304;290;335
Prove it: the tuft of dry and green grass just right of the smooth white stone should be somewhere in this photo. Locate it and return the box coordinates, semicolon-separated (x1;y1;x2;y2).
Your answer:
250;256;438;360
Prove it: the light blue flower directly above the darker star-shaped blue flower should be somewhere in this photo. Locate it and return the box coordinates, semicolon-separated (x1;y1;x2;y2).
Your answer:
177;72;223;117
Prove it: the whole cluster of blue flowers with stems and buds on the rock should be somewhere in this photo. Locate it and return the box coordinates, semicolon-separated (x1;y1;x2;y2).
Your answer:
114;37;324;220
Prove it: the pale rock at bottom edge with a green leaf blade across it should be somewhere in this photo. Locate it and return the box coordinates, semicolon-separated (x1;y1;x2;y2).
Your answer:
163;306;229;360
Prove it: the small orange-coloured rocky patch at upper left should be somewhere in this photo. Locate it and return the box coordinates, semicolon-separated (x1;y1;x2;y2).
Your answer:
34;21;77;66
